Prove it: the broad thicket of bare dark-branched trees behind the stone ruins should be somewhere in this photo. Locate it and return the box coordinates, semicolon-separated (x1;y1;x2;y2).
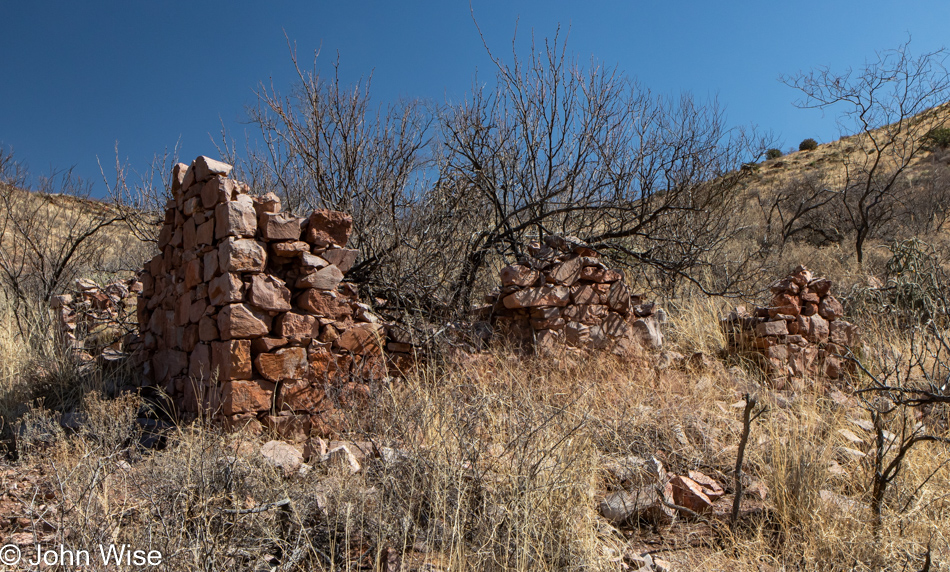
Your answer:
246;31;767;320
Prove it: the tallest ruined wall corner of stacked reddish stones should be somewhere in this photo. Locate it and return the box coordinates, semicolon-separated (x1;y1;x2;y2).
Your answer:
138;157;412;438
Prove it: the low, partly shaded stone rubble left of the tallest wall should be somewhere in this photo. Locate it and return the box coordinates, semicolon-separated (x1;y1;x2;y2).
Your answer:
50;278;142;362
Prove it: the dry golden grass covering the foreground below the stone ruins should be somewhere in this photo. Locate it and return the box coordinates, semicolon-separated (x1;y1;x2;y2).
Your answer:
0;288;950;570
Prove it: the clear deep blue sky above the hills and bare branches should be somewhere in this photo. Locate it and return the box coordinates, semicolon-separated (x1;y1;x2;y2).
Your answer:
0;0;950;196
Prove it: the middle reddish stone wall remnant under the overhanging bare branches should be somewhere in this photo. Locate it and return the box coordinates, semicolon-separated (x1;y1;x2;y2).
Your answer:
479;236;663;355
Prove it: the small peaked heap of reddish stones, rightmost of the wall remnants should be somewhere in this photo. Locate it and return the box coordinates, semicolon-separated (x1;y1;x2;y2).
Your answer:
722;266;859;388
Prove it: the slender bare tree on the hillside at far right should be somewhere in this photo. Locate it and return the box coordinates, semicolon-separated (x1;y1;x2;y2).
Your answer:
782;40;950;263
